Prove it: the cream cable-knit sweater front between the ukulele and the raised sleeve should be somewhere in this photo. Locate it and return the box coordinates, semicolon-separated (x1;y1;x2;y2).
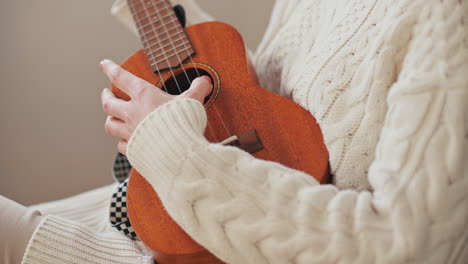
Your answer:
256;0;420;189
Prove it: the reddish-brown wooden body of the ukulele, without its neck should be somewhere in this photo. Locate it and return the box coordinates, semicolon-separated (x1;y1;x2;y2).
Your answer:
113;22;329;264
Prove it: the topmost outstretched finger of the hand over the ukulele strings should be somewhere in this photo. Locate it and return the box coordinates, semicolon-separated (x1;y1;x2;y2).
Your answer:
100;59;155;98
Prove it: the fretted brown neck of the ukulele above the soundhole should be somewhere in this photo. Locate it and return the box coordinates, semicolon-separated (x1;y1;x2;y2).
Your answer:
127;0;195;72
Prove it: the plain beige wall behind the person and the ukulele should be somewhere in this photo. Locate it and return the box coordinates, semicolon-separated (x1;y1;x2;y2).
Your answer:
0;0;273;204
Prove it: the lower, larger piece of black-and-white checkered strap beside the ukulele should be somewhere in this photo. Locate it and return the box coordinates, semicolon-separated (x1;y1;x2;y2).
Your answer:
109;179;139;240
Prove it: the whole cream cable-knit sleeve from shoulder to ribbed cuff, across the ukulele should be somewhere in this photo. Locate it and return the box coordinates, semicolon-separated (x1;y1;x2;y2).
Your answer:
128;3;468;263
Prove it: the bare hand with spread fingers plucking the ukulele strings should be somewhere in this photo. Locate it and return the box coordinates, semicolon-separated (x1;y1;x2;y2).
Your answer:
100;60;212;155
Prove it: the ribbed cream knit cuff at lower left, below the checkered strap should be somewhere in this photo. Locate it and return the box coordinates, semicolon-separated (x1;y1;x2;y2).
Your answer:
21;215;153;264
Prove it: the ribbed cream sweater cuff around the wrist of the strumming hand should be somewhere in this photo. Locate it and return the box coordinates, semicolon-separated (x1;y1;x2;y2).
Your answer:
127;98;209;179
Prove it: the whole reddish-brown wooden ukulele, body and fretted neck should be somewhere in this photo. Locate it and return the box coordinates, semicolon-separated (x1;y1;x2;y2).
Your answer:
112;0;329;264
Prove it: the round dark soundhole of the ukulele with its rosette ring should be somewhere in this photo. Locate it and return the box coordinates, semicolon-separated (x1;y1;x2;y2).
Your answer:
157;62;221;109
